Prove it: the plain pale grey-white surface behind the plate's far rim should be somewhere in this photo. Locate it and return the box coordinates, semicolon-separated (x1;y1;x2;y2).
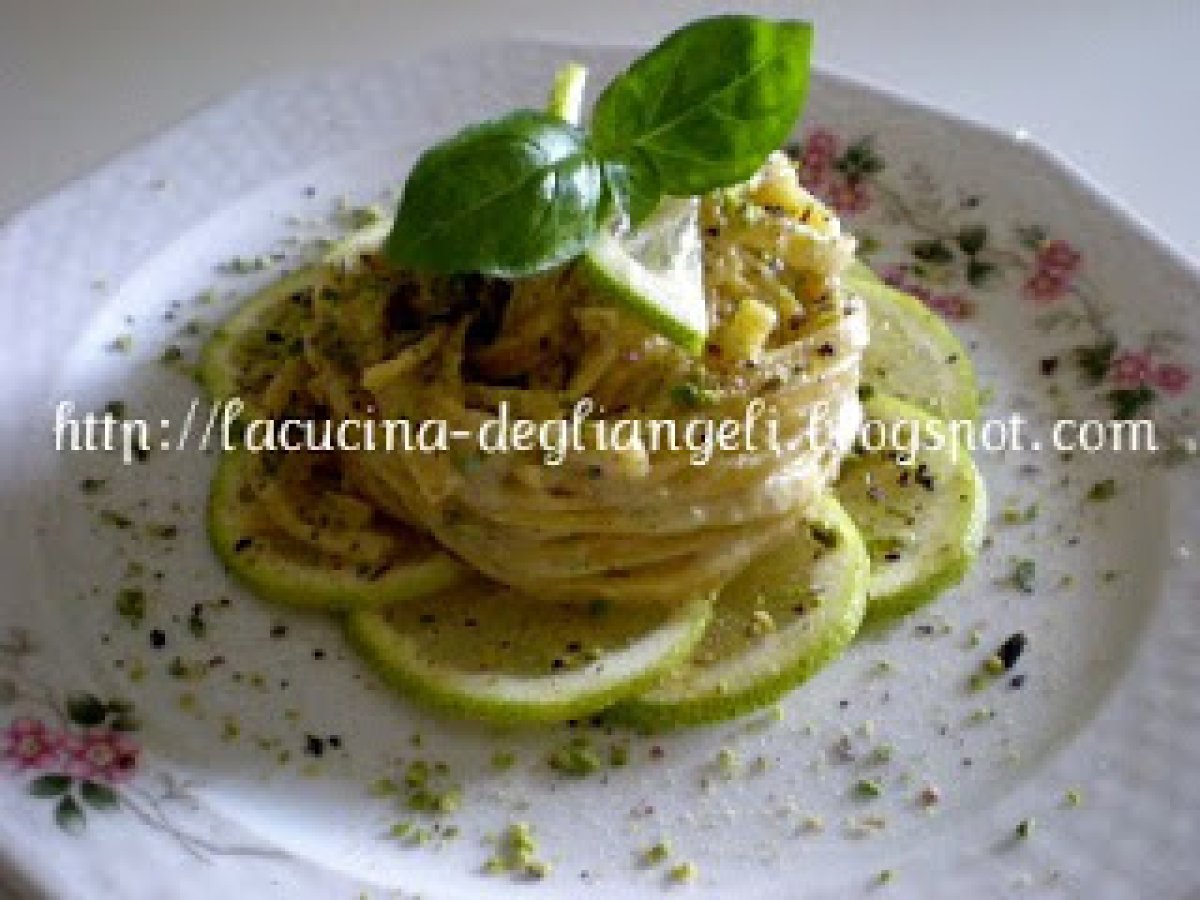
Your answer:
0;0;1200;257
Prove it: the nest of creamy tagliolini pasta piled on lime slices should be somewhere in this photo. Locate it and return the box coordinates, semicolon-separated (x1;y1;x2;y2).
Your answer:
250;154;868;602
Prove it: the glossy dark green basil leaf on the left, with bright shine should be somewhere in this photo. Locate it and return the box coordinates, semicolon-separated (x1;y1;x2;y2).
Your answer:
384;110;610;278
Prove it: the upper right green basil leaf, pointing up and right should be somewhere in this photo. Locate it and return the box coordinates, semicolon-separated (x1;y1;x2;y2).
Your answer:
592;16;812;197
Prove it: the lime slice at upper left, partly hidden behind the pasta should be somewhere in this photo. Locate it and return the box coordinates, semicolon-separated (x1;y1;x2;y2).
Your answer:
199;221;388;419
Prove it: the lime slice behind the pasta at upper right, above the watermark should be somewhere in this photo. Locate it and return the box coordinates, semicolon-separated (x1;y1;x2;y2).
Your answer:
846;262;979;421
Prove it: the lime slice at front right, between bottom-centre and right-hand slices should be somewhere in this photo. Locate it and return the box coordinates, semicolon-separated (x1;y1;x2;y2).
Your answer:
610;497;868;728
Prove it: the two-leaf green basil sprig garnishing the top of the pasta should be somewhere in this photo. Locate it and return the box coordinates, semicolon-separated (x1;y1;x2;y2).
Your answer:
384;16;812;277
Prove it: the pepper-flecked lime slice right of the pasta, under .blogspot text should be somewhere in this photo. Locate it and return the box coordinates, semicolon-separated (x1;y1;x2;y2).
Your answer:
834;396;986;620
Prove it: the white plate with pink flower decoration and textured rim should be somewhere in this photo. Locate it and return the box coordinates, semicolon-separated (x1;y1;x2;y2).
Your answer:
0;43;1200;898
